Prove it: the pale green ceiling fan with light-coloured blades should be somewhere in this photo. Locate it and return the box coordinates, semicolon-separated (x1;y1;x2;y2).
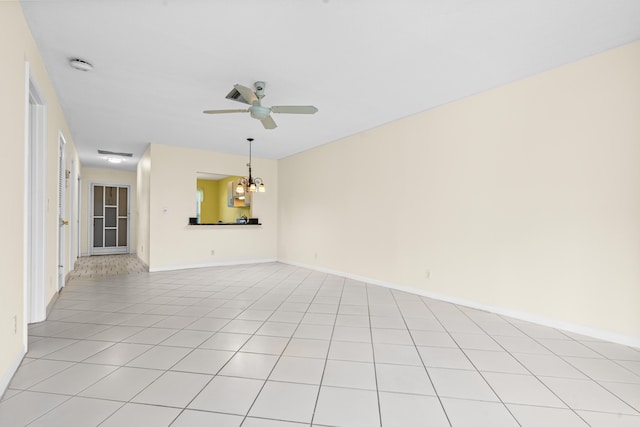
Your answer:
203;82;318;129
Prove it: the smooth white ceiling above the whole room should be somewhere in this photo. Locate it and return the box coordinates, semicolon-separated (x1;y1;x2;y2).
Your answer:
21;0;640;170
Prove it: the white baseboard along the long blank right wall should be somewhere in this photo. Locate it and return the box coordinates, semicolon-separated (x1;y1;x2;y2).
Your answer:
279;260;640;348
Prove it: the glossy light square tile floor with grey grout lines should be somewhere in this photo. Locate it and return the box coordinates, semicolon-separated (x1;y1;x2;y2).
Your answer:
0;263;640;427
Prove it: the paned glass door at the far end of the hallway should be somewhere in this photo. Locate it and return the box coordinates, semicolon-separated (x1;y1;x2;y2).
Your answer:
89;184;130;255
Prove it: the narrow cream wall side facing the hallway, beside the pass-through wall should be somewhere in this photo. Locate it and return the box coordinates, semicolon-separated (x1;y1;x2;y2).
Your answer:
136;146;151;267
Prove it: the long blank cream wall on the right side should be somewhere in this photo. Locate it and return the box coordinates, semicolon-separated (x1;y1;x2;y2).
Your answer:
278;42;640;346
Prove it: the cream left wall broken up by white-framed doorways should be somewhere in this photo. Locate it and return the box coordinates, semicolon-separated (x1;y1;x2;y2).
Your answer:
0;1;77;393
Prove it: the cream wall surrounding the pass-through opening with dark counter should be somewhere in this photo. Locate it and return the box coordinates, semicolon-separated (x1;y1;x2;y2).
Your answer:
149;144;278;271
